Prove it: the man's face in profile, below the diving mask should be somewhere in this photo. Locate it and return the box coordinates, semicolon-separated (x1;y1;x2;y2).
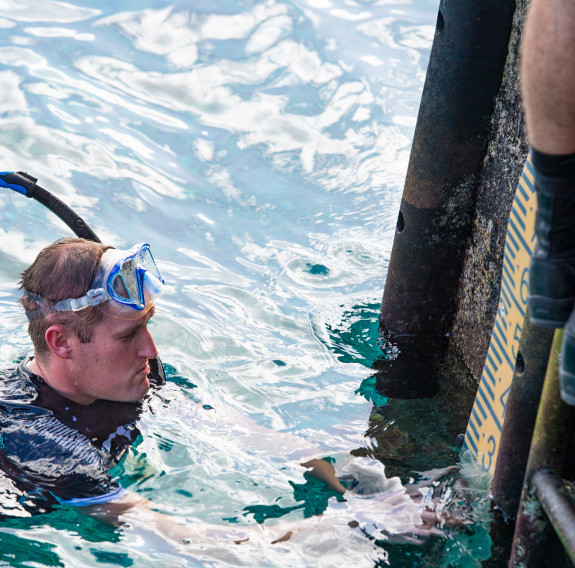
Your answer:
74;308;158;404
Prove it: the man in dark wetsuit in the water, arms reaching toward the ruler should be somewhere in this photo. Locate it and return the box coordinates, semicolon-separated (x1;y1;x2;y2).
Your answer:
0;238;446;544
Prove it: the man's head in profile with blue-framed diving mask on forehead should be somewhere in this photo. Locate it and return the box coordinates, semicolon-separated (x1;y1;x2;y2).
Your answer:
20;238;163;404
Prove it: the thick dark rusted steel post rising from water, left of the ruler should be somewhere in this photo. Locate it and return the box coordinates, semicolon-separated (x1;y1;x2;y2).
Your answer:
381;0;515;375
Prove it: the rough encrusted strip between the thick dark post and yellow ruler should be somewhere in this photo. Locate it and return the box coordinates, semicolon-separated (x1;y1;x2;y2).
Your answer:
451;0;528;382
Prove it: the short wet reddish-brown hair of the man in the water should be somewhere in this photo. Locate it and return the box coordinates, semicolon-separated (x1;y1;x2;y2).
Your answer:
20;237;113;357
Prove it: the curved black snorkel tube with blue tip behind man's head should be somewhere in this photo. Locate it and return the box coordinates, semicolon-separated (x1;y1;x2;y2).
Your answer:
0;172;101;243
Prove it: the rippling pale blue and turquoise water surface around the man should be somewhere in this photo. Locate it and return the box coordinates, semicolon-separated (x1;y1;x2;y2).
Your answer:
0;0;498;567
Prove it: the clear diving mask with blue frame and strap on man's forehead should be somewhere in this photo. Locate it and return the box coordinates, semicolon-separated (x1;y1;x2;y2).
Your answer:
26;244;166;320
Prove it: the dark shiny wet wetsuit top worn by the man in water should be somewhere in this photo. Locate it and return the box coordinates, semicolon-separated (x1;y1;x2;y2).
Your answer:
0;358;165;514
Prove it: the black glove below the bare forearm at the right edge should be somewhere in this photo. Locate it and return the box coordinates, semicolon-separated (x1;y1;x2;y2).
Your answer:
529;150;575;328
